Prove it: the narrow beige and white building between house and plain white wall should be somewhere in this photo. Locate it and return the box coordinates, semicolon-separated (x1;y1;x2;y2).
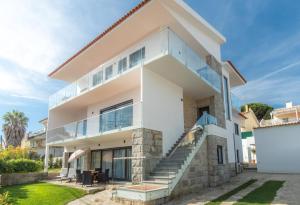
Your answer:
242;105;259;165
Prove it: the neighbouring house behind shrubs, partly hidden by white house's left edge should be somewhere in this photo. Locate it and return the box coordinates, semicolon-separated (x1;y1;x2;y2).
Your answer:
22;118;64;158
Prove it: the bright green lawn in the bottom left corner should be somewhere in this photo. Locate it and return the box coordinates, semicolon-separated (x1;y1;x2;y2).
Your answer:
0;183;85;205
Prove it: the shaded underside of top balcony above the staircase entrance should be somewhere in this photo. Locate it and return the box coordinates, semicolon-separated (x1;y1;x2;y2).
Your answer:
145;55;218;99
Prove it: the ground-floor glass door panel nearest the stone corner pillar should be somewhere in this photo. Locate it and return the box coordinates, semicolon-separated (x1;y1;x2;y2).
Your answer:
114;149;126;179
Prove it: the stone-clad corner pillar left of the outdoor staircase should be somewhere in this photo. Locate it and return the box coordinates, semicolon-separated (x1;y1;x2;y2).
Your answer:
132;128;163;183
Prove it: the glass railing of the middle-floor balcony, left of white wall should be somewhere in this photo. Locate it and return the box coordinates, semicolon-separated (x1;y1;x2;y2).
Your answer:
47;103;141;143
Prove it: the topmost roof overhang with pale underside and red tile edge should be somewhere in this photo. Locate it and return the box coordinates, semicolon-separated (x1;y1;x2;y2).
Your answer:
49;0;225;82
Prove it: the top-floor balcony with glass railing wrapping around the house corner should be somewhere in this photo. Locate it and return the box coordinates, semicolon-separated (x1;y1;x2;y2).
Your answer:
49;28;221;109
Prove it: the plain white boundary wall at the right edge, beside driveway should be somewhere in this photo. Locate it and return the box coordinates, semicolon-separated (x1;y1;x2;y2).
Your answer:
254;125;300;173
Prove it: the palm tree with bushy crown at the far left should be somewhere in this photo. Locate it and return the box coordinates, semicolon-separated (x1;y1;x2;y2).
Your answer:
2;110;28;147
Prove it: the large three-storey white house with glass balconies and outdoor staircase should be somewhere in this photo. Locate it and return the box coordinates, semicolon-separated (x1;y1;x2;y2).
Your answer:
45;0;246;202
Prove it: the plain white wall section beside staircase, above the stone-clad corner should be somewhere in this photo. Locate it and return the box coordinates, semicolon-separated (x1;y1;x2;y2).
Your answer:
143;68;184;154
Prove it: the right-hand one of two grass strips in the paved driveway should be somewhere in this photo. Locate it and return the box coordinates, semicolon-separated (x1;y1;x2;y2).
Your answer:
235;181;284;205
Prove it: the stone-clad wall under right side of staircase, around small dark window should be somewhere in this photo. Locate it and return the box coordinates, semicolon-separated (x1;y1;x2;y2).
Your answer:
171;135;231;198
